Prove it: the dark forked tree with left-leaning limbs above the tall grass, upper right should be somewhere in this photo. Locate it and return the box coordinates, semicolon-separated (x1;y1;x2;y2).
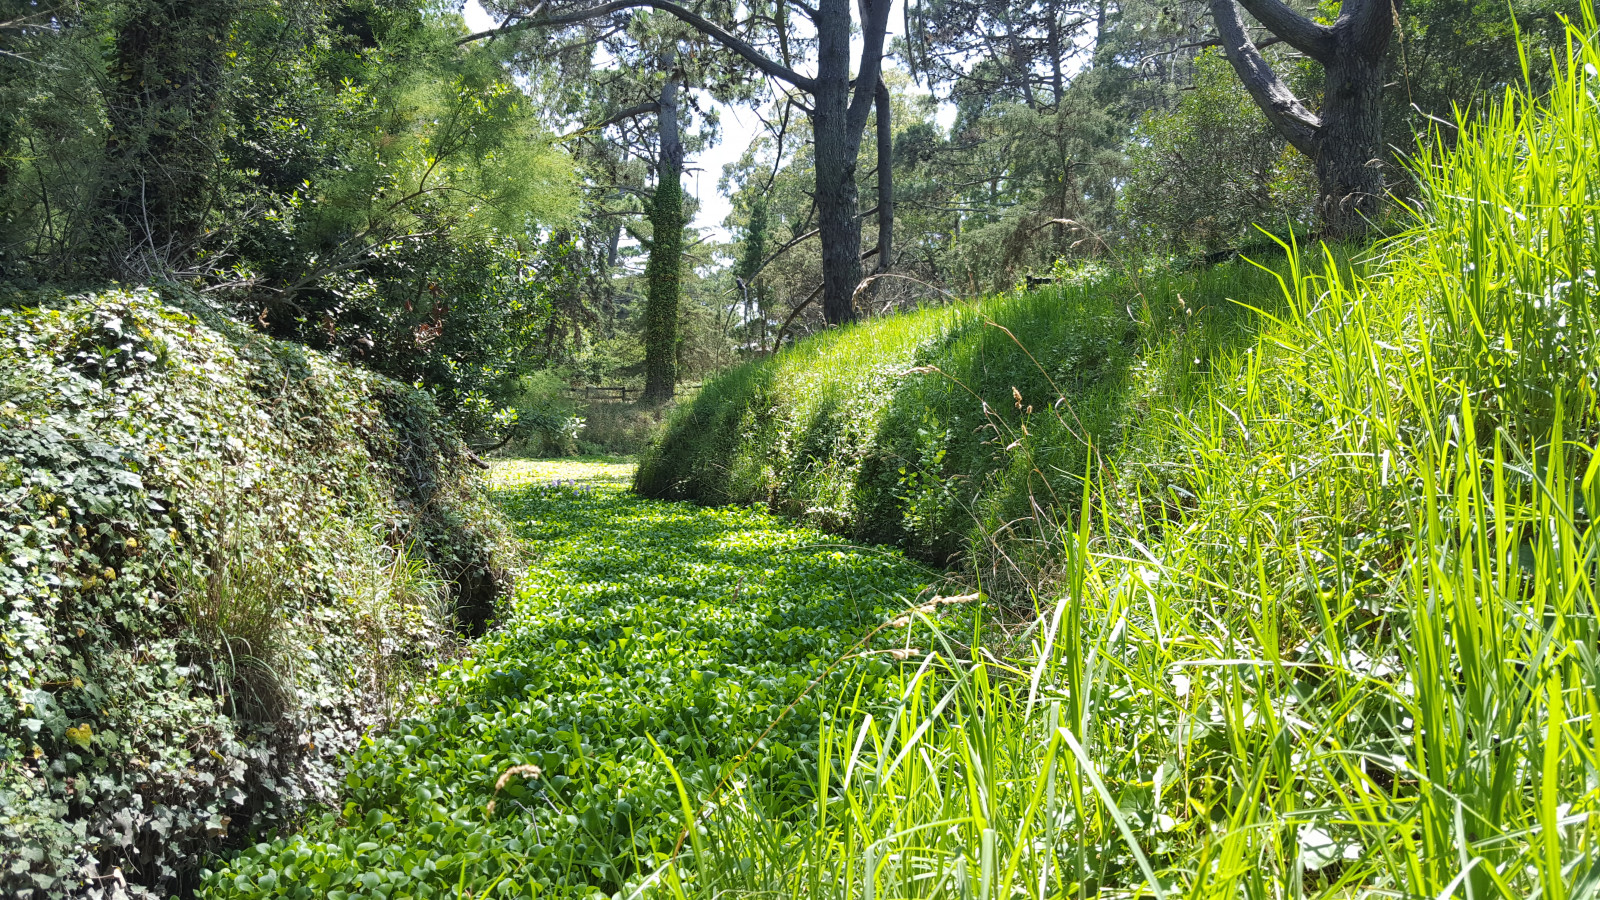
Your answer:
1211;0;1398;237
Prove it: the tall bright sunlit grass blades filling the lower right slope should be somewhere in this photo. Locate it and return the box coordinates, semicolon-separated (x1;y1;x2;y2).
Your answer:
658;21;1600;900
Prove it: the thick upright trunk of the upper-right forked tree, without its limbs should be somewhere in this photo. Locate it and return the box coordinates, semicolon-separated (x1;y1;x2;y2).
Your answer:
1315;46;1384;239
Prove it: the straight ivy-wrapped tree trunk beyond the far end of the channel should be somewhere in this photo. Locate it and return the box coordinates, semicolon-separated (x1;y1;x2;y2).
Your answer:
645;48;683;404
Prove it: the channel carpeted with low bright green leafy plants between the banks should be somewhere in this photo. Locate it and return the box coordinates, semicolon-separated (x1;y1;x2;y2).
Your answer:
208;461;928;900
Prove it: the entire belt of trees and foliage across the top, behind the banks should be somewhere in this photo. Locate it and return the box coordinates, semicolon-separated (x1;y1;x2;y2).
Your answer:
0;0;1581;435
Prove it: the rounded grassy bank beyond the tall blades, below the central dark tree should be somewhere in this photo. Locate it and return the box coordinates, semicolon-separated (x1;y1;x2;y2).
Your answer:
637;245;1305;570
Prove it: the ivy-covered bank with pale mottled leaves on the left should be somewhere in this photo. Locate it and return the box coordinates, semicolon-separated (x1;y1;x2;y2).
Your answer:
0;291;510;898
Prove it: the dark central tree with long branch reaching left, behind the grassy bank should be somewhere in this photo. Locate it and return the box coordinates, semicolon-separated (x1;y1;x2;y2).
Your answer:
462;0;890;325
